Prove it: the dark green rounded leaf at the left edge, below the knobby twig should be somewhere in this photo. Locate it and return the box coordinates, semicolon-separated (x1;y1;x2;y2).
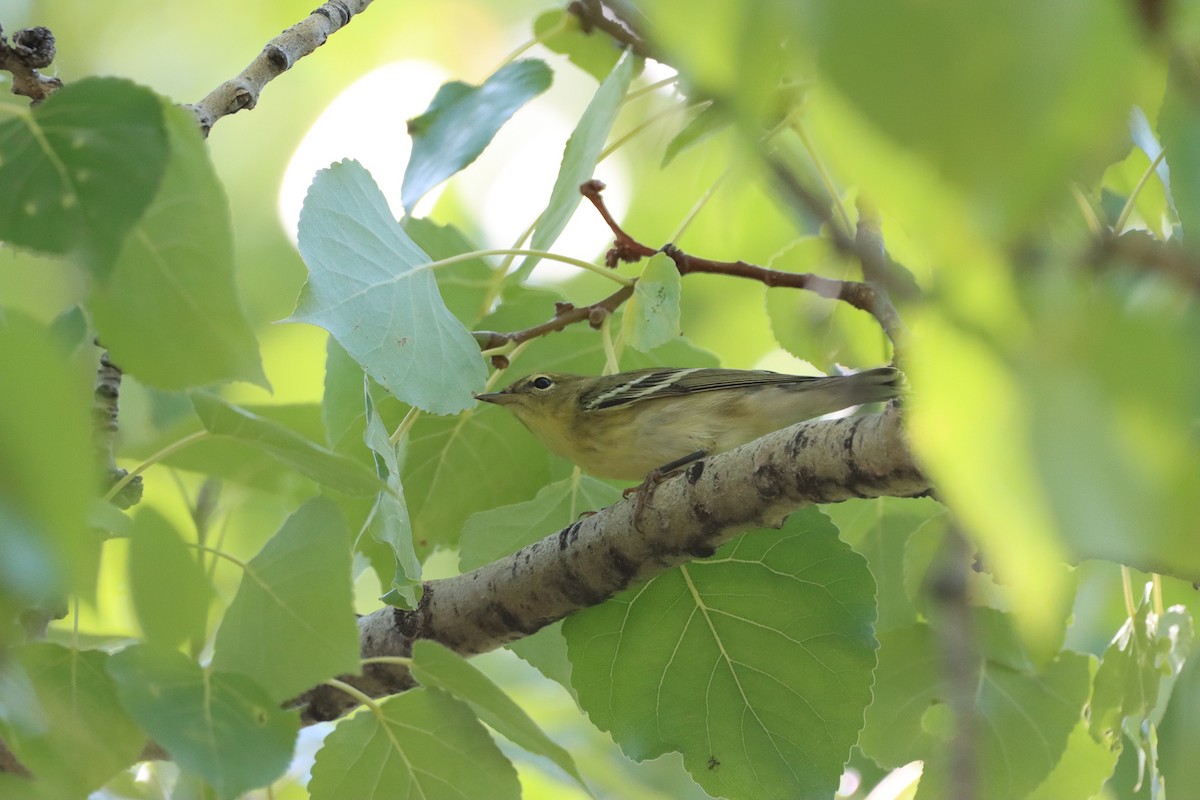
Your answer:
0;78;169;277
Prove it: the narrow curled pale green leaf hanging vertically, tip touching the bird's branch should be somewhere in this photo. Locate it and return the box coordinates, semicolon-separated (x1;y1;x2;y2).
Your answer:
365;397;421;608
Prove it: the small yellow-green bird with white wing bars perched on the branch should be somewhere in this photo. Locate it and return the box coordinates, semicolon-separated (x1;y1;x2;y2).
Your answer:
478;367;901;481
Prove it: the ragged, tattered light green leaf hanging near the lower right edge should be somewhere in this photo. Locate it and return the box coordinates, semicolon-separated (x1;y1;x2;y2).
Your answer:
1088;584;1194;746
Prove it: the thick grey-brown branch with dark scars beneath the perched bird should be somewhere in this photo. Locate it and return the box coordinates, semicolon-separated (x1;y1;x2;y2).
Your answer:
300;409;930;722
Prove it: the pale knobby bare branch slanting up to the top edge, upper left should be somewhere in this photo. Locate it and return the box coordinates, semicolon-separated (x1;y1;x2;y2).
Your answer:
191;0;371;136
